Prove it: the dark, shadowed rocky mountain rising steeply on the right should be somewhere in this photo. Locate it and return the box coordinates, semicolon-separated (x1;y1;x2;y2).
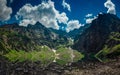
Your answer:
73;14;120;53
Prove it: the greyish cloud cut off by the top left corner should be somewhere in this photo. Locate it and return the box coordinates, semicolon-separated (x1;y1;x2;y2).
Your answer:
0;0;12;21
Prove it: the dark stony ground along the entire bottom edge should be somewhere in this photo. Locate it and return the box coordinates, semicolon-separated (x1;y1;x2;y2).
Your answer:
0;58;120;75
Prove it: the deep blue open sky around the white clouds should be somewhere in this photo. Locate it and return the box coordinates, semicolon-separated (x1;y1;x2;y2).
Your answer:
9;0;120;23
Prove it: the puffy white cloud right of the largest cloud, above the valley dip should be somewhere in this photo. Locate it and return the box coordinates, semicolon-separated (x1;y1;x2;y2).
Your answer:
66;20;82;32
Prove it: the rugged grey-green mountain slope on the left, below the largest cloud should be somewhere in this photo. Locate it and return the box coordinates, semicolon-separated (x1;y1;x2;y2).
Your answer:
0;23;68;51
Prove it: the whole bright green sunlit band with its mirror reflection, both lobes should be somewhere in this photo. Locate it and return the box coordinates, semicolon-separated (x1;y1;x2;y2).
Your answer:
4;46;84;66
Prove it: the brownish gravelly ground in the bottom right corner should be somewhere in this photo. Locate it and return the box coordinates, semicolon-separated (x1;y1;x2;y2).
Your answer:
63;60;120;75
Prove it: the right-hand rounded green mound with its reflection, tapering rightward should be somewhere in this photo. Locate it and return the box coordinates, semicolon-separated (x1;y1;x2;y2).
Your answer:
56;47;84;65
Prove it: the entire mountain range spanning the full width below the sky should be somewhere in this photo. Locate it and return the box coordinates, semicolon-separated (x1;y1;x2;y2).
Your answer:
0;14;120;60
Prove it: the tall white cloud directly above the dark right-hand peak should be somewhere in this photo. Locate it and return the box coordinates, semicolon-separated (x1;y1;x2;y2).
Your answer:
104;0;116;14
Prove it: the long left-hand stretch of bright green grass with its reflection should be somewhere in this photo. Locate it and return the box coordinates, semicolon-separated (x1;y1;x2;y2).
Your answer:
4;46;54;65
